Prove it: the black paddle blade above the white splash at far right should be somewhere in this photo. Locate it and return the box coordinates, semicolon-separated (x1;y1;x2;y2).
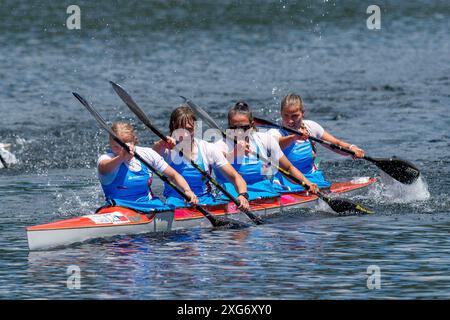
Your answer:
367;157;420;184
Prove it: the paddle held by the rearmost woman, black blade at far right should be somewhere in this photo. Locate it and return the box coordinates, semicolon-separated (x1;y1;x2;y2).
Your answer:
254;117;420;184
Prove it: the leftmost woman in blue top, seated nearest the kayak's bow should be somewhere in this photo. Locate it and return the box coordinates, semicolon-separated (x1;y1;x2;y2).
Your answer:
97;122;198;212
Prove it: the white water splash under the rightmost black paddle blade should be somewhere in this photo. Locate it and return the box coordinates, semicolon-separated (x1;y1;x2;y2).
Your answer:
368;172;431;203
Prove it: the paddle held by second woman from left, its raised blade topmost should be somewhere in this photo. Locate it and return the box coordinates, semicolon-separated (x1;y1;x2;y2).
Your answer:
110;81;264;224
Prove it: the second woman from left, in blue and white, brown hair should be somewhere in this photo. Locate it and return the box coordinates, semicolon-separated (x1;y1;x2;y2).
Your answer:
153;106;249;210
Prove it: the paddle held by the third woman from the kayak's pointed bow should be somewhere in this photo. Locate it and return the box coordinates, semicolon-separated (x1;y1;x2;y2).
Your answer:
181;96;373;213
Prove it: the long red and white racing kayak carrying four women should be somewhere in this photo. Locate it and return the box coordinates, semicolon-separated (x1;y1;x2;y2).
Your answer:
26;178;376;250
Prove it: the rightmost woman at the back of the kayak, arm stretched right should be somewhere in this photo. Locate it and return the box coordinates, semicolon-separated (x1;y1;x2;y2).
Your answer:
268;93;364;191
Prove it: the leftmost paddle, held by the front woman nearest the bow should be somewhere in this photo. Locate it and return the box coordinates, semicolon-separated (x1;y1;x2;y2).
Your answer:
73;92;247;228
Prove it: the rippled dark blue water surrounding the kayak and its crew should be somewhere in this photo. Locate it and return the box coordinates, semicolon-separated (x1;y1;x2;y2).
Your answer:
0;1;450;299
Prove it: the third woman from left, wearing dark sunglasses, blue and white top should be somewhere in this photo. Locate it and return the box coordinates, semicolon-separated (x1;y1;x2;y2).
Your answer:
216;102;319;200
